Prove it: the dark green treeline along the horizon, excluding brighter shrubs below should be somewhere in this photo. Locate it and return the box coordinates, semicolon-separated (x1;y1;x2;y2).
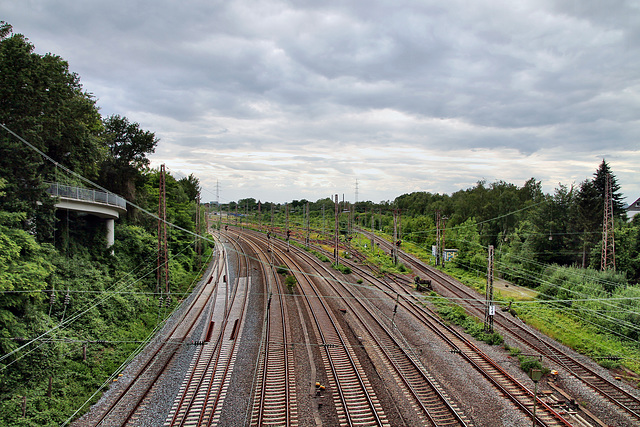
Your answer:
219;160;640;285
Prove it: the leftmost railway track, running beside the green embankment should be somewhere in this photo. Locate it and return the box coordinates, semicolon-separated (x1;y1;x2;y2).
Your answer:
79;241;225;426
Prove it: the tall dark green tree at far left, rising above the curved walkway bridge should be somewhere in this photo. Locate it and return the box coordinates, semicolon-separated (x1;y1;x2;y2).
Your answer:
0;22;104;240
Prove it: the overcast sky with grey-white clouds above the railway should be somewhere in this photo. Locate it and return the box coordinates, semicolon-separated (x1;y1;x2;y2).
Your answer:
0;0;640;206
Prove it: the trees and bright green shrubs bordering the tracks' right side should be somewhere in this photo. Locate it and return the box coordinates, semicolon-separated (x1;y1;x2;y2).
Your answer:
229;160;640;350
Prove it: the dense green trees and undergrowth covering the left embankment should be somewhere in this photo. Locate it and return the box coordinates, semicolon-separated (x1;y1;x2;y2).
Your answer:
0;23;210;426
